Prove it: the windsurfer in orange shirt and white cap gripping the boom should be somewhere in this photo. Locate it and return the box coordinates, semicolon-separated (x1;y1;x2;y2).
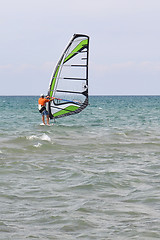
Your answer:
38;94;54;125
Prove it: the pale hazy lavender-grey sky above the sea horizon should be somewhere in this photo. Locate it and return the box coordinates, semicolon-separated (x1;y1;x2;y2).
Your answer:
0;0;160;95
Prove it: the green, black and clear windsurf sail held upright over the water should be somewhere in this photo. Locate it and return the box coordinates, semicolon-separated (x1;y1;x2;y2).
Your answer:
48;34;89;119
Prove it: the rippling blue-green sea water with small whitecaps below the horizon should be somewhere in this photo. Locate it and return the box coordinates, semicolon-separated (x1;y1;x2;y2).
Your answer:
0;96;160;240
